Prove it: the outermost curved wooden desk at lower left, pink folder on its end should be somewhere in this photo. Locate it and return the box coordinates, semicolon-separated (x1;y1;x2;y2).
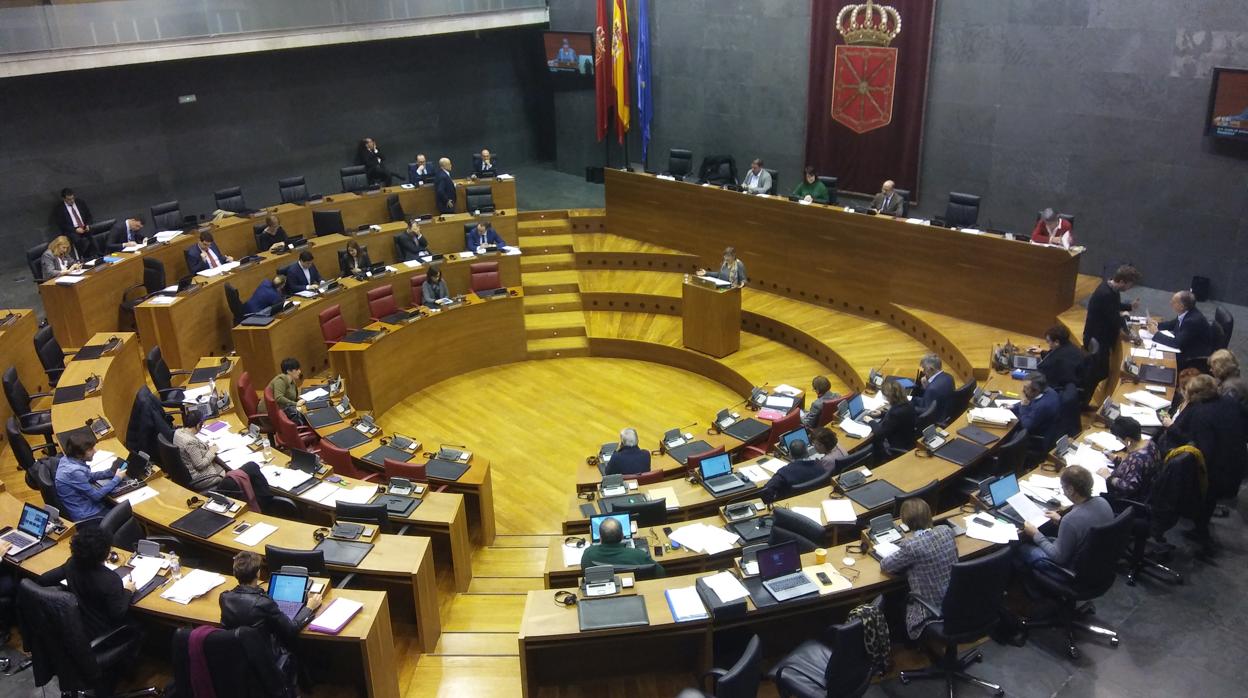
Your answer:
0;493;399;698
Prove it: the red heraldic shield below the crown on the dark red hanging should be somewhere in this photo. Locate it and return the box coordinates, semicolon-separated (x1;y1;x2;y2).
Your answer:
832;44;897;134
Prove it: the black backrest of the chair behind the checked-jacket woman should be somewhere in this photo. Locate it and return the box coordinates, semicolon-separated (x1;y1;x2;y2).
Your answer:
941;547;1013;638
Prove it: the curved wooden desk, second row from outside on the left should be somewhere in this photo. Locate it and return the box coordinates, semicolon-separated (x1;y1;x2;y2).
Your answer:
52;333;441;651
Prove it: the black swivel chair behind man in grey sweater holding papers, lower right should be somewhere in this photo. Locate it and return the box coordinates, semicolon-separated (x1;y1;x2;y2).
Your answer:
1023;507;1134;659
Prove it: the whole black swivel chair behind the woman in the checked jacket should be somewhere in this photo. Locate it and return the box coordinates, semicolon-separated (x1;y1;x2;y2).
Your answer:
899;547;1013;696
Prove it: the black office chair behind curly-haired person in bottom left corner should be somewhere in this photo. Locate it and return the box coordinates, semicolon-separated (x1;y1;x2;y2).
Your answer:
17;579;160;698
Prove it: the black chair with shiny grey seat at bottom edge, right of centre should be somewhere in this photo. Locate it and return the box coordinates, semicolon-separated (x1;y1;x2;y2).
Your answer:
768;618;875;698
